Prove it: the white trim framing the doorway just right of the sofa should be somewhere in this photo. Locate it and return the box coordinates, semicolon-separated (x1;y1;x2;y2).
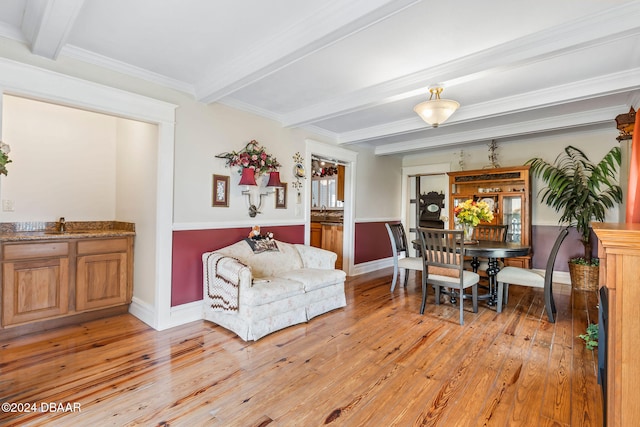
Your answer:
304;138;358;275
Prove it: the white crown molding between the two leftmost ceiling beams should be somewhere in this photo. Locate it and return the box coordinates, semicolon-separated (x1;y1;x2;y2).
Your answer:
61;44;195;96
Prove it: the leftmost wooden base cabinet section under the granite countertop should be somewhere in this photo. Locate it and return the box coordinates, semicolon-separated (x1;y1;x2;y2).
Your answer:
2;242;70;326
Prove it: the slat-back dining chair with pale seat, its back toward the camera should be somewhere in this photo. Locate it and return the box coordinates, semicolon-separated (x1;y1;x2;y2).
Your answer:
418;227;480;325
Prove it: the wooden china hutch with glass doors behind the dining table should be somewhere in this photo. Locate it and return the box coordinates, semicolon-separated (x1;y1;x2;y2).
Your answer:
448;166;533;268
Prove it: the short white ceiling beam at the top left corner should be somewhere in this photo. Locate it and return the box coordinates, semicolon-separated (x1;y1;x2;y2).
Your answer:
22;0;84;60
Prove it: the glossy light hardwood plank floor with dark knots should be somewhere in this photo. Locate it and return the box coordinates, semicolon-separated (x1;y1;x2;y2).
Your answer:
0;269;602;427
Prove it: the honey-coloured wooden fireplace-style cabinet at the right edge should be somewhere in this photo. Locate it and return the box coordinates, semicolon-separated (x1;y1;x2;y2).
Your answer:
592;223;640;427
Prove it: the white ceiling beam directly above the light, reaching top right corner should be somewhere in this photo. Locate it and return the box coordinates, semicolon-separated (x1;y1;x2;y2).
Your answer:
283;2;640;127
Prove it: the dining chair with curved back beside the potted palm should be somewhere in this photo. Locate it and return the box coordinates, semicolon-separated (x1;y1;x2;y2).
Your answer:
496;228;569;323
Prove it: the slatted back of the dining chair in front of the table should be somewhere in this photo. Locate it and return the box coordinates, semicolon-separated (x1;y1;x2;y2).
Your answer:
418;227;464;275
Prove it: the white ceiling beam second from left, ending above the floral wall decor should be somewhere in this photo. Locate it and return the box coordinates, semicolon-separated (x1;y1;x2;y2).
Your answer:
196;0;420;103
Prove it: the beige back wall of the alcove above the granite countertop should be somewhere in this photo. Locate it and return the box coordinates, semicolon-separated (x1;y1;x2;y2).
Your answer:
0;95;117;222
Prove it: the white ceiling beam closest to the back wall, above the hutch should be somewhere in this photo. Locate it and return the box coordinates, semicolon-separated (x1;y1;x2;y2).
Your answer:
374;105;626;155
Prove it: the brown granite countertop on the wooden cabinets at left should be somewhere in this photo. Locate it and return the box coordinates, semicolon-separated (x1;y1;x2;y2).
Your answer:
0;221;136;242
